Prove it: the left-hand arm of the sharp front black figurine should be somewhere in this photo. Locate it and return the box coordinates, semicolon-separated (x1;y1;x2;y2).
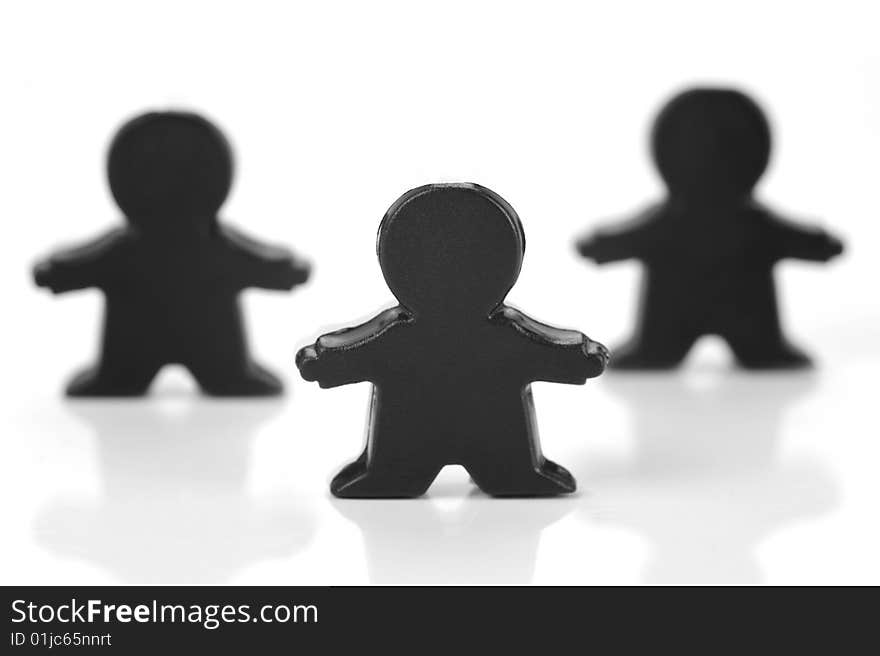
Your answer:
296;307;409;387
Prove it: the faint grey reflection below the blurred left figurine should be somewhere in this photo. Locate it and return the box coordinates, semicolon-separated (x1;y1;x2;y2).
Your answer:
35;397;313;583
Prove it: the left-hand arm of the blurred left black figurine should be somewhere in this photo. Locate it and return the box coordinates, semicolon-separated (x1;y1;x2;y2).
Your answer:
33;228;128;294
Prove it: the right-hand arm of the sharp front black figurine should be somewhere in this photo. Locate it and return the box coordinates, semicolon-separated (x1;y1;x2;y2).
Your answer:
496;306;609;385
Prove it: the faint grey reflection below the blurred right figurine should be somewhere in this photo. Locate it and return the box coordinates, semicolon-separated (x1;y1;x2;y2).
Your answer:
579;371;838;583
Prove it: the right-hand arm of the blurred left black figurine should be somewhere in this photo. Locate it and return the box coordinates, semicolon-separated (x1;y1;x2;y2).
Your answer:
220;226;311;290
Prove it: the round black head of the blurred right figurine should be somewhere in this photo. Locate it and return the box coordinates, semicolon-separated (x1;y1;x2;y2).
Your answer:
652;89;770;200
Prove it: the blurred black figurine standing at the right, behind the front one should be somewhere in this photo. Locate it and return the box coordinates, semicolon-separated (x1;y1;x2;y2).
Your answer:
577;88;843;369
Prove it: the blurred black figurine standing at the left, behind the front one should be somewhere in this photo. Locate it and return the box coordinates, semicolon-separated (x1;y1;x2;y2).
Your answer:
34;112;309;396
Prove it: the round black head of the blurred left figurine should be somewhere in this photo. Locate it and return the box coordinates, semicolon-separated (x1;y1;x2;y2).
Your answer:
107;112;232;228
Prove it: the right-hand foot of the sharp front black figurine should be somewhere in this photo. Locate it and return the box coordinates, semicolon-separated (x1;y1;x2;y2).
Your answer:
467;457;577;497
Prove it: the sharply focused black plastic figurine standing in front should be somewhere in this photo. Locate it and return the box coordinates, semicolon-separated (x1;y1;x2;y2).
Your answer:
297;184;608;497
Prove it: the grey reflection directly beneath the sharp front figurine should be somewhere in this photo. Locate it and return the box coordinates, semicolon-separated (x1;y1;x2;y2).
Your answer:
334;471;573;584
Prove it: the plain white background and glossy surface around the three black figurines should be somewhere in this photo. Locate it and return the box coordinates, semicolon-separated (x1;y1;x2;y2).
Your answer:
0;0;880;584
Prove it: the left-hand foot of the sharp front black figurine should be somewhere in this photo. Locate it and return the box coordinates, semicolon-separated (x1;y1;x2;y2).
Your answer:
330;452;441;499
